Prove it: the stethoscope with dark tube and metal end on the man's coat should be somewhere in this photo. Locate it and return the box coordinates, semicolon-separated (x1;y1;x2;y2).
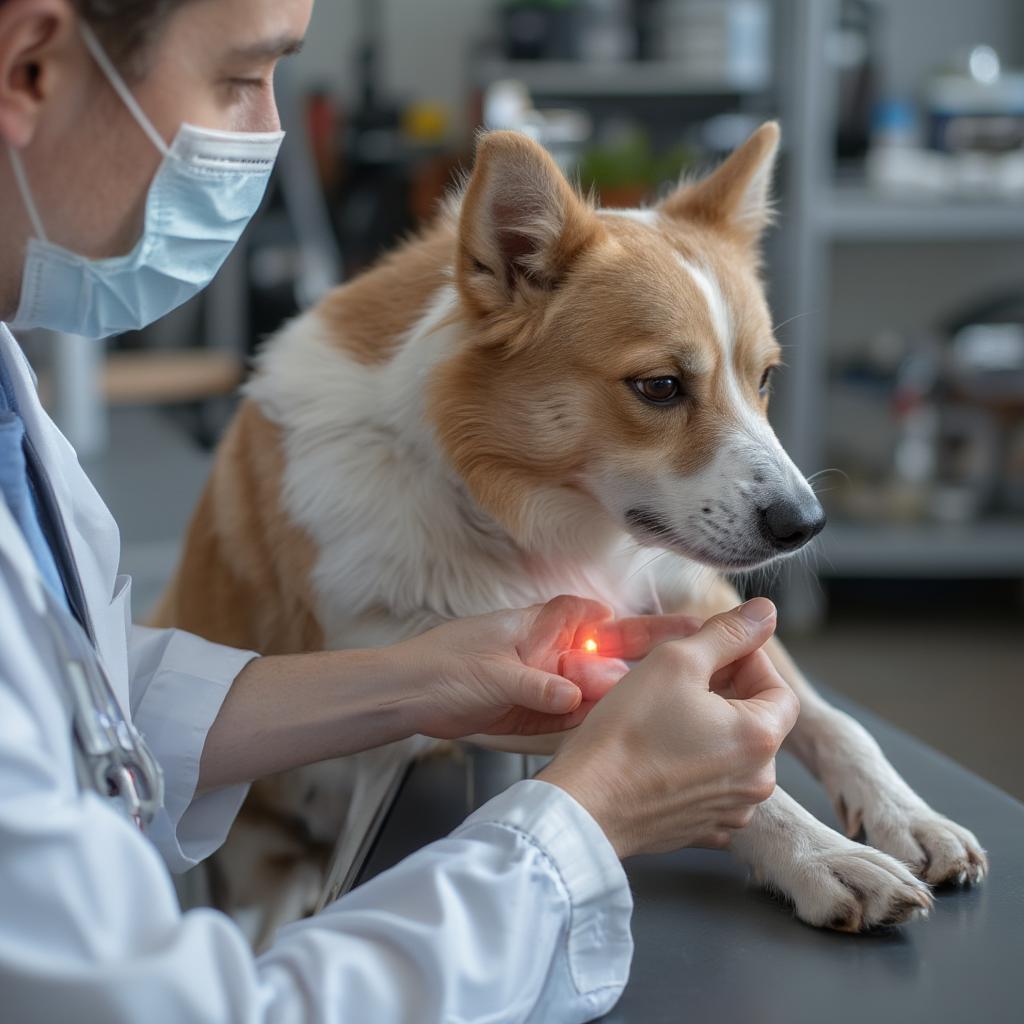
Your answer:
26;423;164;829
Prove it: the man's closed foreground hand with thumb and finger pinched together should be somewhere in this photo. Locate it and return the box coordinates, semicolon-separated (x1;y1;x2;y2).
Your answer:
538;598;800;857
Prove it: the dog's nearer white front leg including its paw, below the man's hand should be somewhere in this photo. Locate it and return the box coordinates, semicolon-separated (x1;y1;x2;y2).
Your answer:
731;790;932;932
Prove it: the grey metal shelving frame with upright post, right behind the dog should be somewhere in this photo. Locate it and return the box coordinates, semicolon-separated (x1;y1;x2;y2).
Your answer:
771;0;1024;627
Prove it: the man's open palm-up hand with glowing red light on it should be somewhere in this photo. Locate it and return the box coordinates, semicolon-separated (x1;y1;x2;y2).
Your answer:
391;597;699;739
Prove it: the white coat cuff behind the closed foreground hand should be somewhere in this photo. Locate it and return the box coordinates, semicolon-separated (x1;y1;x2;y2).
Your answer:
453;779;633;1012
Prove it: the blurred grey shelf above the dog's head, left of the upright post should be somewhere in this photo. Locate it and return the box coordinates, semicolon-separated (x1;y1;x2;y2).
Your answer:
476;59;766;96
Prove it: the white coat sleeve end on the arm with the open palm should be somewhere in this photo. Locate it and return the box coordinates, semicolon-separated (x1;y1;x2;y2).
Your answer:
128;625;256;872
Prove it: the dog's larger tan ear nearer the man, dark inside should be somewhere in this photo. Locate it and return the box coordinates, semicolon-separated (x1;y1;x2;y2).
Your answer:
456;131;603;313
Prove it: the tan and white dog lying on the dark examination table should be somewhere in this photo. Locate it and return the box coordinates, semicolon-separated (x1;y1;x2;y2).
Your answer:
158;124;986;931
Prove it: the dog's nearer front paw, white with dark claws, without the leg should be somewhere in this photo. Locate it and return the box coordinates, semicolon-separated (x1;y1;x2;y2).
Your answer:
763;834;932;932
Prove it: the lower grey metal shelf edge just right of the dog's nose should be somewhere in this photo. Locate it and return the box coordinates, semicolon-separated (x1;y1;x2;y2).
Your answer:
818;517;1024;579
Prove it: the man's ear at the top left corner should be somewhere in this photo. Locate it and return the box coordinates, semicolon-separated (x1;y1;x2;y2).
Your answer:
0;0;77;148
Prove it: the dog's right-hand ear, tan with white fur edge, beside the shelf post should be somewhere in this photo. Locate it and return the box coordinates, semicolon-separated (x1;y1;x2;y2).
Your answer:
662;121;779;244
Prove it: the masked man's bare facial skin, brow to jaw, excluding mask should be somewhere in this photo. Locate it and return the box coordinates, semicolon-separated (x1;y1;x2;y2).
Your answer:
17;0;312;258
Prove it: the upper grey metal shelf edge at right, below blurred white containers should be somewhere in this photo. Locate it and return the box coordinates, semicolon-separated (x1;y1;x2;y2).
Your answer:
815;185;1024;242
